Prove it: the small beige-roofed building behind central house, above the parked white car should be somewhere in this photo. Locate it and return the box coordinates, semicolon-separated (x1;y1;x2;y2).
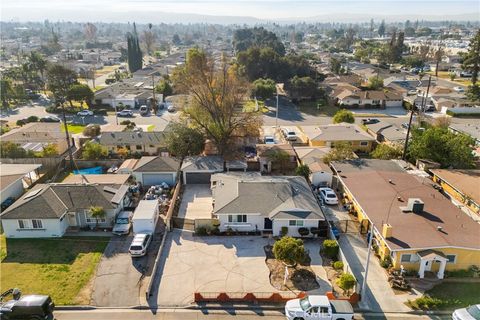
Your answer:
295;147;333;187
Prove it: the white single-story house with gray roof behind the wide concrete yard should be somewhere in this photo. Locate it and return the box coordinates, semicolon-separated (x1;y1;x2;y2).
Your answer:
212;173;325;237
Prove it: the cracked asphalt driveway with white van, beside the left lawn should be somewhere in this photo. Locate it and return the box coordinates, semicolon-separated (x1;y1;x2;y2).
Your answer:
91;223;164;307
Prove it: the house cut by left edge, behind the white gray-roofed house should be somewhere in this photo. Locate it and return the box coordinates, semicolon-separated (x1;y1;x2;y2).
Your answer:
0;163;42;203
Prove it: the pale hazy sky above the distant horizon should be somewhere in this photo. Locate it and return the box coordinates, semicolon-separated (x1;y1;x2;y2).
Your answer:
0;0;480;22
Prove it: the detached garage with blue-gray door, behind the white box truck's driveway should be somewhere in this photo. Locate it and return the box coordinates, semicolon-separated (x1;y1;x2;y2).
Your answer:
133;156;180;187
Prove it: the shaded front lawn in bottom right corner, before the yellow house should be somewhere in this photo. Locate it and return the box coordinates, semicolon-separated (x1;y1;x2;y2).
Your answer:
408;282;480;310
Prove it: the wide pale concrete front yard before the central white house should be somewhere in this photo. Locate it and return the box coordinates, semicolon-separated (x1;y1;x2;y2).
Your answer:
150;230;277;307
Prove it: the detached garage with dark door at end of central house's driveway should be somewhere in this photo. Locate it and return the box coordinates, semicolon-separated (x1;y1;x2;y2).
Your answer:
182;156;223;184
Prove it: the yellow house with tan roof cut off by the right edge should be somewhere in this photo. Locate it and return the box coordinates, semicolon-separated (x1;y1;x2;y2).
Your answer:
430;169;480;215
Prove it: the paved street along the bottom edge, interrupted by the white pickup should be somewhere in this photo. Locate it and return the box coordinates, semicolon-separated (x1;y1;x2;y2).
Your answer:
55;309;451;320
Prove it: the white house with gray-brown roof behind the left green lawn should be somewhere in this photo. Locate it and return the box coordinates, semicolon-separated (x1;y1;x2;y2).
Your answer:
0;183;130;238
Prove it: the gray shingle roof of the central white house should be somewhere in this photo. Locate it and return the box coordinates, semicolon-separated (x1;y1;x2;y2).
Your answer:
212;173;324;220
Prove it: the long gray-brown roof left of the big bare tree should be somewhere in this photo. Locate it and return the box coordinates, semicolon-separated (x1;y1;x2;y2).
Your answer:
98;131;164;146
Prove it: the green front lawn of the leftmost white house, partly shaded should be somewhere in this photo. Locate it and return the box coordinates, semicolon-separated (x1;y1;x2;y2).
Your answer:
0;236;109;305
